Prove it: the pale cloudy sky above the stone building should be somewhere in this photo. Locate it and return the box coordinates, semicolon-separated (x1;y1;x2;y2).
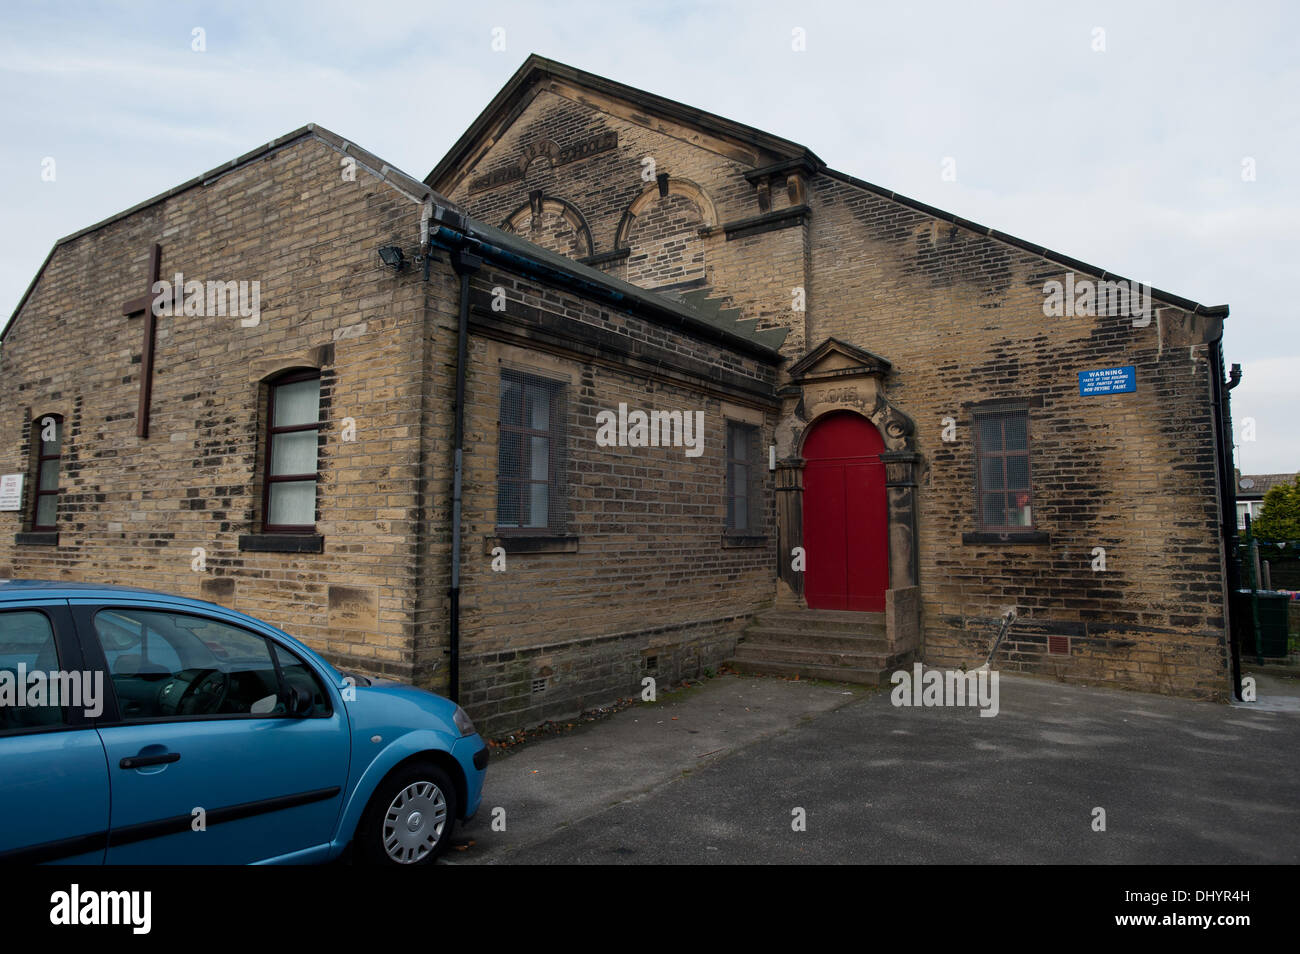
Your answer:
0;0;1300;473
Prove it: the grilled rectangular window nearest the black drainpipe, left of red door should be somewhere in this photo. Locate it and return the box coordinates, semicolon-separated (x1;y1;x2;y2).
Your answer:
497;370;566;533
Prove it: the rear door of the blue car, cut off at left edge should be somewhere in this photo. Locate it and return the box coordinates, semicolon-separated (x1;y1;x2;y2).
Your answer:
0;599;109;864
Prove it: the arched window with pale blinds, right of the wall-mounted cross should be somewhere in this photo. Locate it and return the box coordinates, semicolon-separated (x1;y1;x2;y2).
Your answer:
263;370;321;533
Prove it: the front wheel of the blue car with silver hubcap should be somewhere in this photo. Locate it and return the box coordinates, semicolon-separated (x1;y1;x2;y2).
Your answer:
355;762;456;864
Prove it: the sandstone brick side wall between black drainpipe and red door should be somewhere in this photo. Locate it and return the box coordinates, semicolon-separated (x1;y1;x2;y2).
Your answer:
436;269;775;730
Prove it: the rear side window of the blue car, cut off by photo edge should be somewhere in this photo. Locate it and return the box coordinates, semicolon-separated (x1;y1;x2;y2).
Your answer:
0;610;64;732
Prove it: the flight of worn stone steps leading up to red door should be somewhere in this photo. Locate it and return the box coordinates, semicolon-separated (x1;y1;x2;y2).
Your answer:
727;610;910;685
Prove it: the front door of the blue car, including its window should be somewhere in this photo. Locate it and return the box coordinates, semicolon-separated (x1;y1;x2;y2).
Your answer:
73;600;350;864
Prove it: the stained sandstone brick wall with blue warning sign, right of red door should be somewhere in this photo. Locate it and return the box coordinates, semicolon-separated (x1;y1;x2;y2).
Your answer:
810;177;1227;695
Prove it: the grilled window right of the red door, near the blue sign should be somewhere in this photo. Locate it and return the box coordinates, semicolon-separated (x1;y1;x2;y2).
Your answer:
975;408;1034;530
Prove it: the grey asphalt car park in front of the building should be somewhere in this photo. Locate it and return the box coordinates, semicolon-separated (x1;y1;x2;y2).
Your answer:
443;675;1300;864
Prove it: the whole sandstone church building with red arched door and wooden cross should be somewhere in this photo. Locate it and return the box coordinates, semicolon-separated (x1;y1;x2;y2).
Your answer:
0;57;1235;730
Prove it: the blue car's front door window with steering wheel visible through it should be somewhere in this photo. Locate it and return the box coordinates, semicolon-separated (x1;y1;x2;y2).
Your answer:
95;607;285;721
